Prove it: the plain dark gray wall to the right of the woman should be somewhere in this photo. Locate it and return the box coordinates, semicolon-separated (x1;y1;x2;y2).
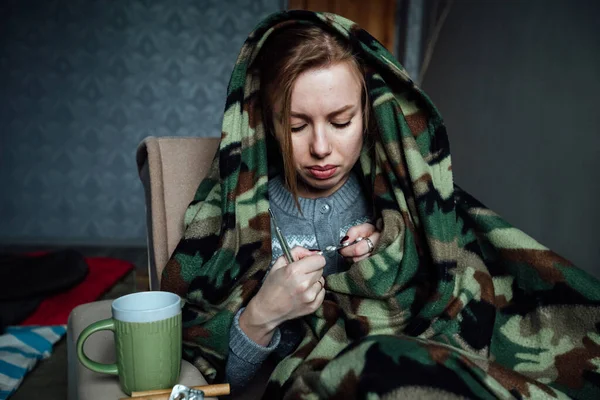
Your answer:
423;0;600;276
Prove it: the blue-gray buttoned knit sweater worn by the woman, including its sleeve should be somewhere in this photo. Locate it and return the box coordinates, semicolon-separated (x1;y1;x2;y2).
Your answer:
225;175;371;391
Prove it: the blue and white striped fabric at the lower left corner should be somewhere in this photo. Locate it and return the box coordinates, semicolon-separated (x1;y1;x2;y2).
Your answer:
0;325;66;400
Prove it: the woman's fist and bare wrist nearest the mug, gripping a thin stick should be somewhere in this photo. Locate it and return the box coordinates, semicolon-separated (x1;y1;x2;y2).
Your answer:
239;247;325;346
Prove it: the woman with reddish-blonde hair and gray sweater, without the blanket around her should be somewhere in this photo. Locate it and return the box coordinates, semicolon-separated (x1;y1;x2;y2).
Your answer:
226;21;379;389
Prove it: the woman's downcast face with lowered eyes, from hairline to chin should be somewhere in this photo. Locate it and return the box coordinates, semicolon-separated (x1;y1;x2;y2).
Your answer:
274;62;363;198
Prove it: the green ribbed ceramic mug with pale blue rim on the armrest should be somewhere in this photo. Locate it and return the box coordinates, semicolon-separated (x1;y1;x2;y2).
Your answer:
77;291;181;394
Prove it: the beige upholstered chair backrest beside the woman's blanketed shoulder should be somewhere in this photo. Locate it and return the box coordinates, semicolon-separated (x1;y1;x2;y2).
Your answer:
136;137;220;290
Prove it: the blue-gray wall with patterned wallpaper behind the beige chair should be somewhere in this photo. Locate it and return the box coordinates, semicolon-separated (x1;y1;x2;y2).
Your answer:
0;0;282;244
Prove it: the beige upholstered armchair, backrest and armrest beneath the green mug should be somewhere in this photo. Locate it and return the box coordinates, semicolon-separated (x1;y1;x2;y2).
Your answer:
67;137;219;400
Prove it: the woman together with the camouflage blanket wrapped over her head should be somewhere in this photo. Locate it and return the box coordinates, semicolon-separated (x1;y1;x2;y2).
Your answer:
162;12;600;398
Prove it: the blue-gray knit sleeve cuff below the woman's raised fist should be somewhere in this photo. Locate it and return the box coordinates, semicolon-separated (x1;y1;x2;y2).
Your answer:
225;308;281;392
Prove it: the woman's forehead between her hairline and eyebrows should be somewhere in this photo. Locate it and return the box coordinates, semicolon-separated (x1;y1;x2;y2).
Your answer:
291;62;362;115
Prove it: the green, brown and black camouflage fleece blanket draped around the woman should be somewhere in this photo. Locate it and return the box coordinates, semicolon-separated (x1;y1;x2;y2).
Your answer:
162;12;600;399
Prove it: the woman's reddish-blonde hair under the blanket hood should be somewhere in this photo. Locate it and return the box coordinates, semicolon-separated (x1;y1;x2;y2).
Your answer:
259;25;370;209
